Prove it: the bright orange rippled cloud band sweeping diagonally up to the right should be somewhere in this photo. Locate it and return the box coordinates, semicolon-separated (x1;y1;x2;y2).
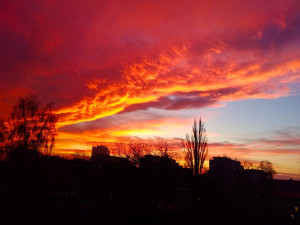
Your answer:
57;41;300;126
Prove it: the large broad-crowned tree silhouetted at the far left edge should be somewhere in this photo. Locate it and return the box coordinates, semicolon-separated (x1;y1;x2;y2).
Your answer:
5;95;57;153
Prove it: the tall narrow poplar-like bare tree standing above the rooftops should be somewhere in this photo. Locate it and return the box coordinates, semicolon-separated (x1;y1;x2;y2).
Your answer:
182;118;208;177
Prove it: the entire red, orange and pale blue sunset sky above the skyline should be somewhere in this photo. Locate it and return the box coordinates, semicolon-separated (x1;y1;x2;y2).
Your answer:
0;0;300;180
